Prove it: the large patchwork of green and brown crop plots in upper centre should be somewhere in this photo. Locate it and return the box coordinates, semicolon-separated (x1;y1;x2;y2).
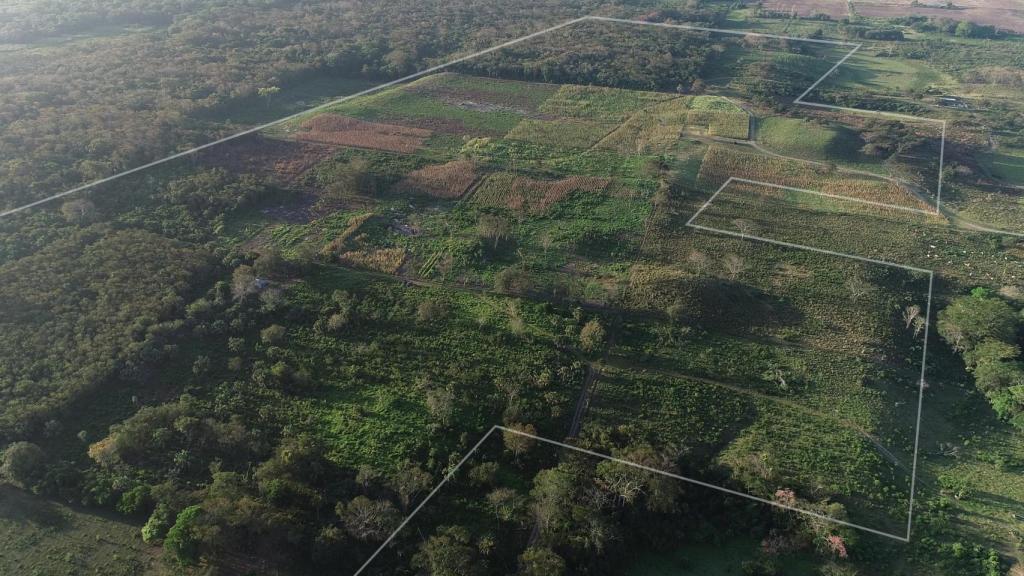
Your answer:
256;69;679;301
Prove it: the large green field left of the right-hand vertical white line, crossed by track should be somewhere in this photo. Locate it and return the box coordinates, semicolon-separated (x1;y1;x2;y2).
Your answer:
610;233;930;535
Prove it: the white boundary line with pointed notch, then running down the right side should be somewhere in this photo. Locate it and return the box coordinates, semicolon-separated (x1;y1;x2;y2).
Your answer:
686;176;935;542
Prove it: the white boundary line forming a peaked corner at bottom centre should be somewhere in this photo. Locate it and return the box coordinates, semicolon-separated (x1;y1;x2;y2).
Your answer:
352;424;909;576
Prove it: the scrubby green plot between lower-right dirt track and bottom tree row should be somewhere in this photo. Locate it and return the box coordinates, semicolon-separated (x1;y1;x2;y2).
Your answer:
583;362;913;535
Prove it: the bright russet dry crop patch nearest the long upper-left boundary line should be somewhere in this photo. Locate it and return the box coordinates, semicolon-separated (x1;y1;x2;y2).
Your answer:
295;114;431;154
